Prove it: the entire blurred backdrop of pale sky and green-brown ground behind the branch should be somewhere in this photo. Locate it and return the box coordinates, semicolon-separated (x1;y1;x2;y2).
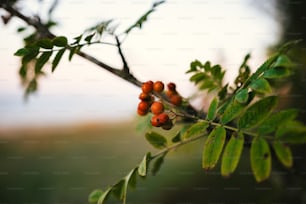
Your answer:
0;0;306;203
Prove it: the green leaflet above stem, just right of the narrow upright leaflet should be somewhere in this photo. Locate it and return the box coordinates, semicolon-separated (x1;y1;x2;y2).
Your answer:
220;100;245;125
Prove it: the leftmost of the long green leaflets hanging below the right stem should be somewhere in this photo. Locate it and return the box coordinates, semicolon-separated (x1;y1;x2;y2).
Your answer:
202;126;226;170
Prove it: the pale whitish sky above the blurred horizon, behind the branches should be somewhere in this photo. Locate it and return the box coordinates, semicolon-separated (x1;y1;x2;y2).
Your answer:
0;0;281;128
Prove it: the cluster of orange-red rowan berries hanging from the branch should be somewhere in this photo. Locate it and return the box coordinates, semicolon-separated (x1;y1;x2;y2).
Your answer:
137;81;182;130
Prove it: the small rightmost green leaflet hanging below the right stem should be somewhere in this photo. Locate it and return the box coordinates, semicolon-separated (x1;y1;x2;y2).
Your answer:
273;140;293;168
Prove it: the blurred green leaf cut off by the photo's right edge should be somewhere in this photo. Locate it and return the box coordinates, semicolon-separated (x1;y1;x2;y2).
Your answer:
275;121;306;144
